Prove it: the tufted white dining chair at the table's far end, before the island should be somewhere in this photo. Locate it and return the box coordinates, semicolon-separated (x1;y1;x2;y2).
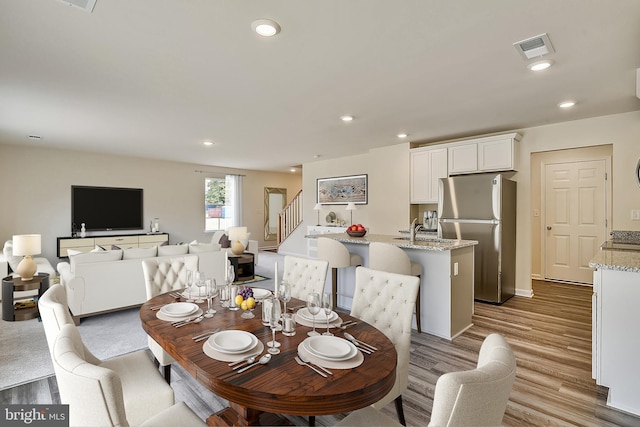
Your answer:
282;255;329;301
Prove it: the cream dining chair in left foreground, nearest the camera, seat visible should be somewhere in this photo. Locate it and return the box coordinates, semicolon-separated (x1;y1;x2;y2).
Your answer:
52;324;206;427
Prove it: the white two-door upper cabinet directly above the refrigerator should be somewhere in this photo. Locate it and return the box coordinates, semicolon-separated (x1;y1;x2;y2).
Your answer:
447;133;520;175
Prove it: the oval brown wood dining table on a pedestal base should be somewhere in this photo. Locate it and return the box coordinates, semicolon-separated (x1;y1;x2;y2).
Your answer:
140;293;397;426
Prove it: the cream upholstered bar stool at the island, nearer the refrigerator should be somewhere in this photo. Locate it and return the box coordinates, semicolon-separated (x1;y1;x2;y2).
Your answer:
369;242;422;332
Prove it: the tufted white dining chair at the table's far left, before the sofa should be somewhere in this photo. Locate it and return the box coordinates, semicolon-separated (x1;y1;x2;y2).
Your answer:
142;255;198;384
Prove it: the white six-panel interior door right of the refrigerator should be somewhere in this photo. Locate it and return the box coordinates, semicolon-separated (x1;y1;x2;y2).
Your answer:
544;160;607;284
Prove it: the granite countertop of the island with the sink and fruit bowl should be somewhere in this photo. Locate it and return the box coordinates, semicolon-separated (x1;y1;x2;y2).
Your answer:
307;233;478;251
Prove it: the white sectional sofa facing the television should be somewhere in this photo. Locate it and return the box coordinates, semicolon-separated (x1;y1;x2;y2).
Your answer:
57;243;225;321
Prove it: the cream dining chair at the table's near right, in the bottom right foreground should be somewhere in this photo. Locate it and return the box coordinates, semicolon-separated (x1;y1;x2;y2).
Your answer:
338;333;516;427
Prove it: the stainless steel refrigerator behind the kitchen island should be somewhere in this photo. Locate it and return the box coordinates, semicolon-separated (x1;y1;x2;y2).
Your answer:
438;173;516;304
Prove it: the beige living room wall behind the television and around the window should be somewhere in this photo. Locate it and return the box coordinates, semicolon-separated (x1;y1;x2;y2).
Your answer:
0;145;301;266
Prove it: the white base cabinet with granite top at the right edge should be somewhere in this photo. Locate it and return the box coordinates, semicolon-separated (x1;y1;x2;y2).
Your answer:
589;246;640;415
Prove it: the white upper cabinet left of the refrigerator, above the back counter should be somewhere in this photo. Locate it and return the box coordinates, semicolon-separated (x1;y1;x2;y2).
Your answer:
411;148;447;204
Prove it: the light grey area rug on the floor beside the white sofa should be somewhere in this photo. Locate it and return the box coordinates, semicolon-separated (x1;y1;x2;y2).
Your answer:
0;308;147;390
